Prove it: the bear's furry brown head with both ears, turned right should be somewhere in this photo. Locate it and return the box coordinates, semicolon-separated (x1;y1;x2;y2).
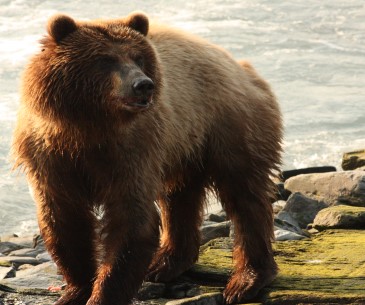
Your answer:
23;13;161;125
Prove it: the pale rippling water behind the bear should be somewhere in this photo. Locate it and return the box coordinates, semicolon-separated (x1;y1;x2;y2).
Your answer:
0;0;365;235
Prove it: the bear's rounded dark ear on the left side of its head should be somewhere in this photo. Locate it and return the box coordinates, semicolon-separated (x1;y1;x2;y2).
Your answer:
47;15;77;43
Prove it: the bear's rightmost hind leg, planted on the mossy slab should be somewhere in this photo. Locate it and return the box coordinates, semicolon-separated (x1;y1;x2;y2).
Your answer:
216;173;277;304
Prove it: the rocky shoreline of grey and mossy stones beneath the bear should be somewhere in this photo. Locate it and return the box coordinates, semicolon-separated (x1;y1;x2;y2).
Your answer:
0;151;365;305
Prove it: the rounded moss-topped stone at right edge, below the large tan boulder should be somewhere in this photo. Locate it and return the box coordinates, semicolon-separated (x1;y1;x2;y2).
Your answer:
313;205;365;230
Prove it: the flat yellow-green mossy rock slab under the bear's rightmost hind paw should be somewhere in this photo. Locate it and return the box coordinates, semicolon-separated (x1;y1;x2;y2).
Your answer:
189;230;365;305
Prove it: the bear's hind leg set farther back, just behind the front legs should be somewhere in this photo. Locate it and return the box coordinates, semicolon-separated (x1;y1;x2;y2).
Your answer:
146;170;205;282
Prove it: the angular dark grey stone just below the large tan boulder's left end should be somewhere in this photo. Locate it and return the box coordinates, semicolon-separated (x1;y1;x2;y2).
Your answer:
277;193;327;228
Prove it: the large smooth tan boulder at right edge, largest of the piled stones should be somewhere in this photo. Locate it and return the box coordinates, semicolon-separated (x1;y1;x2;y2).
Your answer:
285;170;365;207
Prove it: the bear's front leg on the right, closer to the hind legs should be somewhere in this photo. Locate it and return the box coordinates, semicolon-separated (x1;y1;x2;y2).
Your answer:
87;198;159;305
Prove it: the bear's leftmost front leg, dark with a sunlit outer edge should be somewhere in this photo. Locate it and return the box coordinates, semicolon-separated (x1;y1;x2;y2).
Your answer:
34;187;96;305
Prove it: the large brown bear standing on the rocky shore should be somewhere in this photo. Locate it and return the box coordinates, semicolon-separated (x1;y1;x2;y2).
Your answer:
13;13;282;305
